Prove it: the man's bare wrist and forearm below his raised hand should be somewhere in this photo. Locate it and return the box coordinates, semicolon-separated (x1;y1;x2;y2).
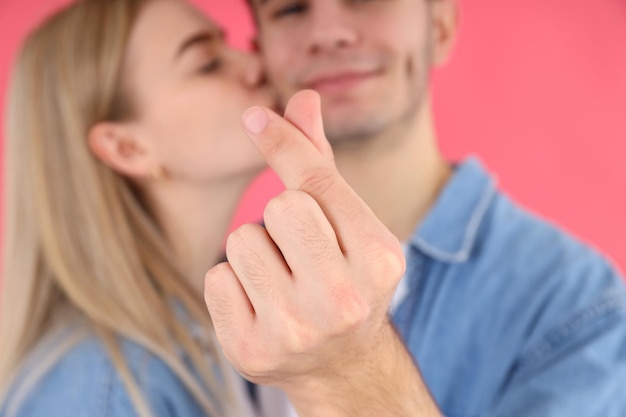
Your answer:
283;323;441;417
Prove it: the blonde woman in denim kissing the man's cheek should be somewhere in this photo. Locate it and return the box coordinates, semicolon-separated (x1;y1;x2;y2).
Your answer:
0;0;272;417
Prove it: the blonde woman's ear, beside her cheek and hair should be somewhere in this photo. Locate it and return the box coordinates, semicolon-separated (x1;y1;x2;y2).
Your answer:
88;122;158;178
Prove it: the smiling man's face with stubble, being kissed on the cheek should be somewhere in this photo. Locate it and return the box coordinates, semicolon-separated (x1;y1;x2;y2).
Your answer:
253;0;438;141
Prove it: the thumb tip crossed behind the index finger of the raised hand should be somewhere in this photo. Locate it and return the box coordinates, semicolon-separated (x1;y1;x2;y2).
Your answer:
284;90;333;158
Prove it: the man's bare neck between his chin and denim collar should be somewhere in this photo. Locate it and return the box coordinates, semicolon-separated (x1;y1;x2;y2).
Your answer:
335;100;452;240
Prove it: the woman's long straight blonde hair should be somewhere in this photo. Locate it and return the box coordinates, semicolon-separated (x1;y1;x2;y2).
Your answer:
0;0;240;417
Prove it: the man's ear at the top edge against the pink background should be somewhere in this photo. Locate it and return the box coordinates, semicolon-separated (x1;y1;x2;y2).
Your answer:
428;0;460;66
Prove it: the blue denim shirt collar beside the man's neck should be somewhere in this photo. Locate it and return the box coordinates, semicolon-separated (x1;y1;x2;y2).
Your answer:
410;157;497;262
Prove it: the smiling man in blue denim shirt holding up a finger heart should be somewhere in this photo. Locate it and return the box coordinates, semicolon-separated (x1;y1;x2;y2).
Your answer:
207;0;626;417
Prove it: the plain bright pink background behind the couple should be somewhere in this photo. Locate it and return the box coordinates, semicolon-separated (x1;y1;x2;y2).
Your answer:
0;0;626;270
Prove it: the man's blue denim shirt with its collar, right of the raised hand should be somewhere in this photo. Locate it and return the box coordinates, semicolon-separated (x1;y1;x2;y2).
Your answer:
393;158;626;417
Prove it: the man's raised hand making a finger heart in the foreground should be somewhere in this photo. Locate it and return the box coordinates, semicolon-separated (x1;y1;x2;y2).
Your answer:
205;91;438;415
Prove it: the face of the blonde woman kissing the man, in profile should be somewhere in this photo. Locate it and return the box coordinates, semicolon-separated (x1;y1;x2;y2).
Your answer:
123;0;274;183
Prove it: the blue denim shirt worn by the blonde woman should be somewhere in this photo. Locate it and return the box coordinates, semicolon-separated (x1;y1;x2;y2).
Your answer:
0;335;211;417
